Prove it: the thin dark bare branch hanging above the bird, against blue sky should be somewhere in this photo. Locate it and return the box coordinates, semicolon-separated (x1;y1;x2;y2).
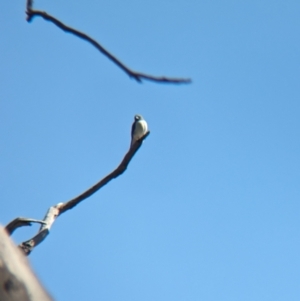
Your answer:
26;0;191;84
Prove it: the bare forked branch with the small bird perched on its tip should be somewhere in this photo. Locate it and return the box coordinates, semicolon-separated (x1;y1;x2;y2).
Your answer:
6;132;150;256
